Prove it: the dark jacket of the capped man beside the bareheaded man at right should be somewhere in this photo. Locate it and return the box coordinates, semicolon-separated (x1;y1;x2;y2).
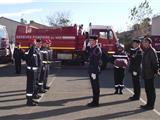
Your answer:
129;48;142;72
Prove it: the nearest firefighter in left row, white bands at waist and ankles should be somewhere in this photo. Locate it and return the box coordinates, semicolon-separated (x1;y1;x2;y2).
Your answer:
26;39;41;106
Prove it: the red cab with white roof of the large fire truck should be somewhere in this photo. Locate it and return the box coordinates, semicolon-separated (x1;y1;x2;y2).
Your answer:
89;24;118;69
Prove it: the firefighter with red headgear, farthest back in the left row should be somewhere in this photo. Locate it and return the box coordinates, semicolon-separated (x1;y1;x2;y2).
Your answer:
39;39;49;93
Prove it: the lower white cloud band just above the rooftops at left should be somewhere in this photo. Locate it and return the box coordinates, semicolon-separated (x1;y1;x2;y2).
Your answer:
0;9;42;17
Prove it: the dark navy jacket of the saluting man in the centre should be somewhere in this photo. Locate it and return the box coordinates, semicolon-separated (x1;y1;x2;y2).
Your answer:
88;45;102;74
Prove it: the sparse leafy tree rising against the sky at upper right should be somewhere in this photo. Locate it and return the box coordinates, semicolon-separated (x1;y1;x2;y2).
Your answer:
129;0;153;35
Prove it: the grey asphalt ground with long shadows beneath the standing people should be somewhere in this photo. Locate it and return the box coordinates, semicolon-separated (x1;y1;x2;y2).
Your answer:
0;63;160;120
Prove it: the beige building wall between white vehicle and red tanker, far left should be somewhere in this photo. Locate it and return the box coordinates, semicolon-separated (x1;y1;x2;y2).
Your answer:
0;17;20;41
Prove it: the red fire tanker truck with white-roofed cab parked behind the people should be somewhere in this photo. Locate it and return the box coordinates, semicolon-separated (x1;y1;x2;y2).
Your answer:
15;25;117;66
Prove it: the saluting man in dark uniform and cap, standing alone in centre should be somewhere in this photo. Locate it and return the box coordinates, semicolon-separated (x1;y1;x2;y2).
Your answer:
87;36;102;107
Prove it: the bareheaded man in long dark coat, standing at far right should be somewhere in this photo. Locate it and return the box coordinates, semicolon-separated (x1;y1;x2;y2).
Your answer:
140;37;159;110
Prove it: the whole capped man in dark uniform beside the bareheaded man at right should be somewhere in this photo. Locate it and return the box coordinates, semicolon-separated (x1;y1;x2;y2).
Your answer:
129;39;142;101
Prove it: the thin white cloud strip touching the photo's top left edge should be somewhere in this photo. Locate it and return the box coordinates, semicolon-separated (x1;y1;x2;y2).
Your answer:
0;0;33;5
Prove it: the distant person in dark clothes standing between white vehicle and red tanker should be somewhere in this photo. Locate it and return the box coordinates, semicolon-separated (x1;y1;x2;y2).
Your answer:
13;43;24;74
